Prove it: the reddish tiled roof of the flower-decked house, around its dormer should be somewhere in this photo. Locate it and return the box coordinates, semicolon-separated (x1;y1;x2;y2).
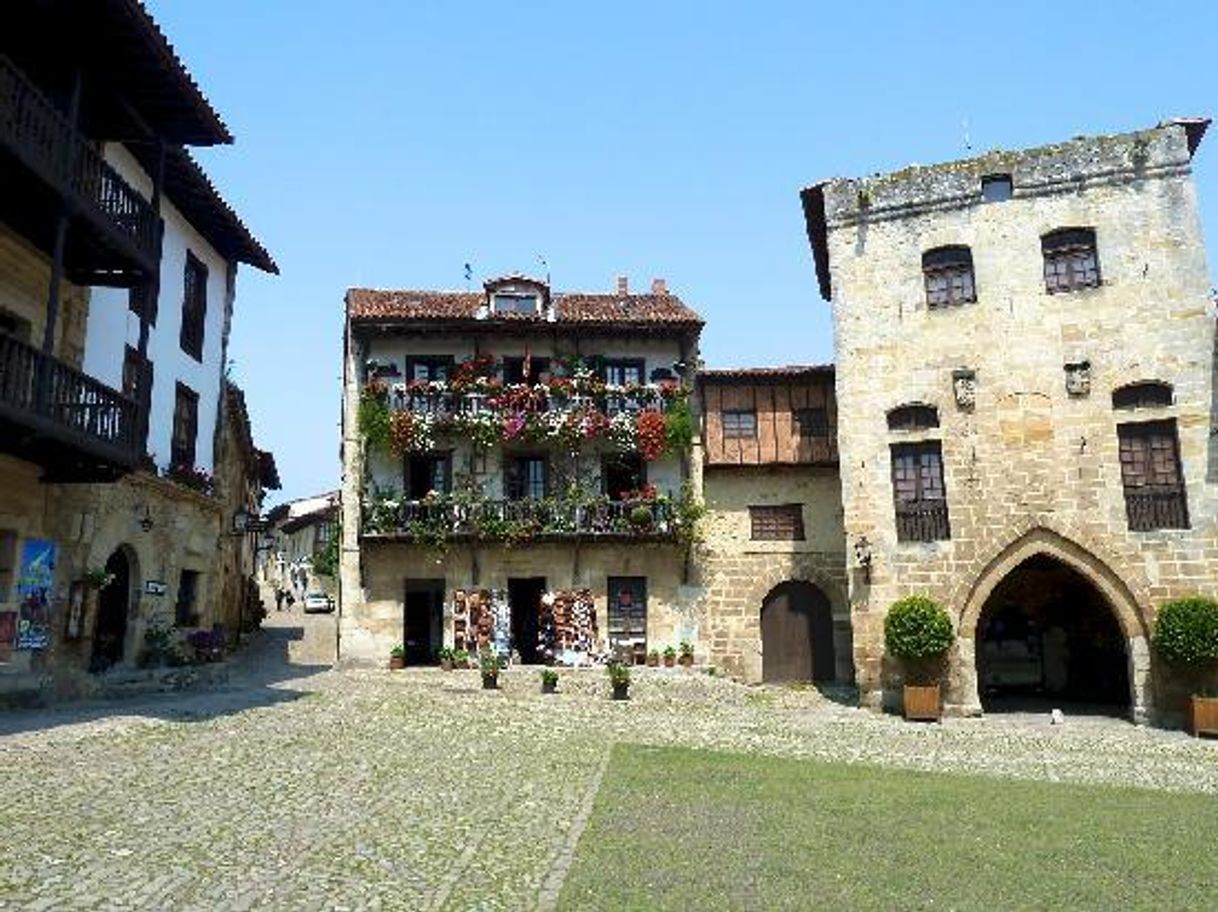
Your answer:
347;289;703;328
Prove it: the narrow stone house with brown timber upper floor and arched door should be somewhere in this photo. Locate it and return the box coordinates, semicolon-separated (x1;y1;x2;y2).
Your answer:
695;365;854;683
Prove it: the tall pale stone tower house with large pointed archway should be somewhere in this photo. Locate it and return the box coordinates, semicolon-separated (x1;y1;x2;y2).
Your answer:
801;121;1218;720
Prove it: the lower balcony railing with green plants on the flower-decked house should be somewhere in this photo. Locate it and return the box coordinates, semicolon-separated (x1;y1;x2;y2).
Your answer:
364;497;678;543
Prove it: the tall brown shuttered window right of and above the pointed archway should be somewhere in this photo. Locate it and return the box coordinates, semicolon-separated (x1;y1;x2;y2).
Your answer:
1117;418;1191;532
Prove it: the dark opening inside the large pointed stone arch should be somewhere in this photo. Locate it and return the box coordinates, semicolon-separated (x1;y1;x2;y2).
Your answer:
977;554;1132;716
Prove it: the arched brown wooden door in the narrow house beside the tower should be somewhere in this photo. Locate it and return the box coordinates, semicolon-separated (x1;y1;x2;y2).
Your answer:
761;580;837;683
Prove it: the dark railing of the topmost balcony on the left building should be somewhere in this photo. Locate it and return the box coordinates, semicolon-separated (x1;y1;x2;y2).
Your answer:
0;55;157;267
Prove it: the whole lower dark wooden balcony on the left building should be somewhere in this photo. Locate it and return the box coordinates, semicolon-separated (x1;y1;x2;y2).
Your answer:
0;332;139;482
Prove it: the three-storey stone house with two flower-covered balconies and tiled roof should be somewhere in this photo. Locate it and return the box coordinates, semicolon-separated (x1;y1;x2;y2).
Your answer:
340;275;702;662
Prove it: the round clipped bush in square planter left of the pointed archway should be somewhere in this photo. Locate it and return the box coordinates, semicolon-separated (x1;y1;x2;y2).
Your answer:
884;595;955;721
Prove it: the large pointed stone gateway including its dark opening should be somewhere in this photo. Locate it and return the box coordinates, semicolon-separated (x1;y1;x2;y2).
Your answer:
949;528;1151;721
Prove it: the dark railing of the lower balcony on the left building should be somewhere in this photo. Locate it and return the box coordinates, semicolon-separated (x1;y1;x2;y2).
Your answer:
0;332;138;464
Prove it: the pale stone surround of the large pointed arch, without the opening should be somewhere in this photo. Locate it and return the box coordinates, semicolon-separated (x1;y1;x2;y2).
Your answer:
949;528;1152;722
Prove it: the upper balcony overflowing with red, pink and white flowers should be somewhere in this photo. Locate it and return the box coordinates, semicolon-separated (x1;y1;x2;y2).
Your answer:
359;365;693;461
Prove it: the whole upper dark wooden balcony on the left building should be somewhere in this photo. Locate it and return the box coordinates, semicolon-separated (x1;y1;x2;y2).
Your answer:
0;55;158;286
